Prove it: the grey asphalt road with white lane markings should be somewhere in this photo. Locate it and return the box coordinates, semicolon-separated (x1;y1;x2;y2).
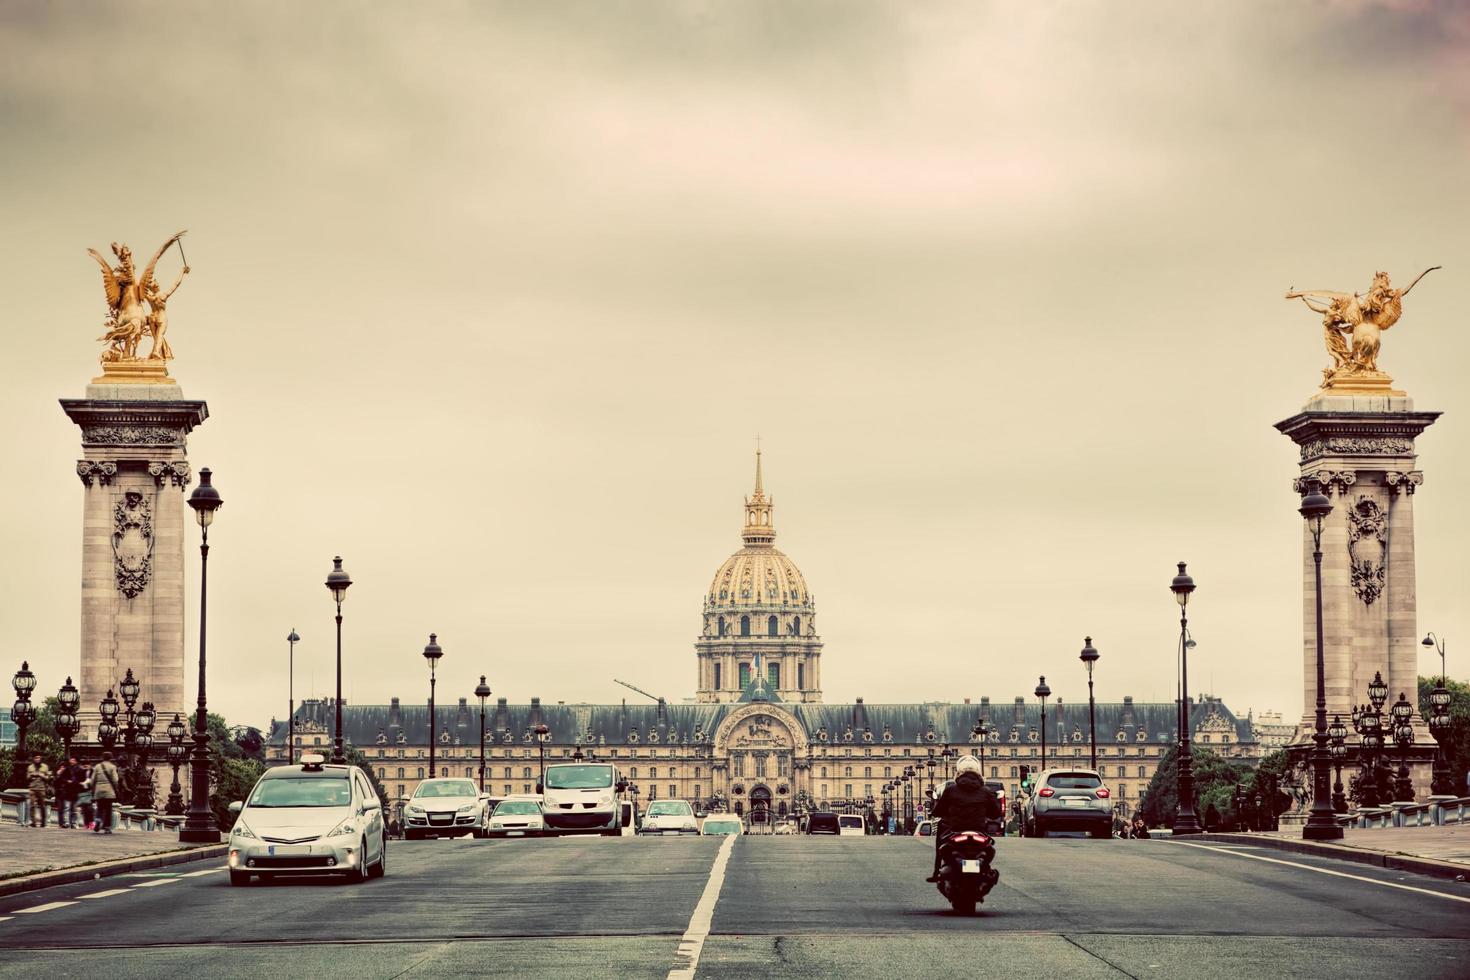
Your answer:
0;837;1470;980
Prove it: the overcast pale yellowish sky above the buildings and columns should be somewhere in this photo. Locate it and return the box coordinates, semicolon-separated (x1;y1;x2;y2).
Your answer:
0;0;1470;726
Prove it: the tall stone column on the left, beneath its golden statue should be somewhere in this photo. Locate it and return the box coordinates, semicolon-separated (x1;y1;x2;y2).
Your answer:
62;383;209;734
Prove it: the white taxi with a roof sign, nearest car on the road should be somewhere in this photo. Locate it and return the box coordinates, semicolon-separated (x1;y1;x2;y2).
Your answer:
226;752;388;884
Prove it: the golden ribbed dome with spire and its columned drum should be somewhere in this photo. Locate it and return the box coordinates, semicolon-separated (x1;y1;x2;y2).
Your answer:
694;450;822;704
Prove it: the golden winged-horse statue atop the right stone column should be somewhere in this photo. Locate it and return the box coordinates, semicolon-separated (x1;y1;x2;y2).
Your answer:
1286;266;1441;388
